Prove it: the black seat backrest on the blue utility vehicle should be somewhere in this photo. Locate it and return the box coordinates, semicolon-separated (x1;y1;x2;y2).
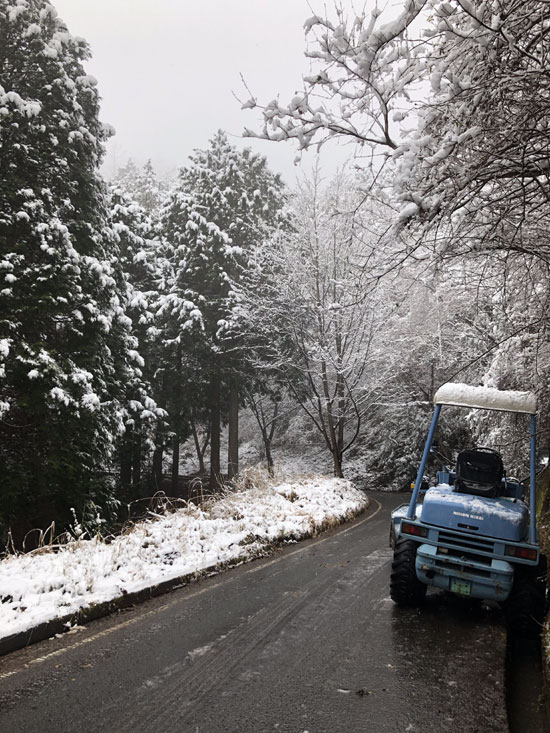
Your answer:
454;448;504;497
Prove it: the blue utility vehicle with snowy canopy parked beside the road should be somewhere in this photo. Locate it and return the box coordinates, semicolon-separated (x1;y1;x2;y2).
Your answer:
390;383;546;637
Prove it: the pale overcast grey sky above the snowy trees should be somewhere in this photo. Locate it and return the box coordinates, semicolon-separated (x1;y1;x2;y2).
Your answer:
52;0;370;183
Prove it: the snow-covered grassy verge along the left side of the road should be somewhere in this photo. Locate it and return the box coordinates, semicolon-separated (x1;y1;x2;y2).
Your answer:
0;476;367;638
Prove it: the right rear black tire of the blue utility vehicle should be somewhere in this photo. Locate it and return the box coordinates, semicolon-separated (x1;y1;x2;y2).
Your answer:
505;555;547;639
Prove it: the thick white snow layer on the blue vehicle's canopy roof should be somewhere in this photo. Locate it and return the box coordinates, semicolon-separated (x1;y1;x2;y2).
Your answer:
434;382;537;415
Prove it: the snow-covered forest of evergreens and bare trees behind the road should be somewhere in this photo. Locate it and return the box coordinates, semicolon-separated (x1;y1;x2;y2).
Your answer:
0;0;550;546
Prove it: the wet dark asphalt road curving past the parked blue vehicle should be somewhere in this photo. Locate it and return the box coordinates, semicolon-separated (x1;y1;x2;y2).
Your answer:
0;493;508;733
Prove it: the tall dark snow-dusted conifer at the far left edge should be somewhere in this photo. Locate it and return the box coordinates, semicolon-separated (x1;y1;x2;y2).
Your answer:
0;0;155;532
